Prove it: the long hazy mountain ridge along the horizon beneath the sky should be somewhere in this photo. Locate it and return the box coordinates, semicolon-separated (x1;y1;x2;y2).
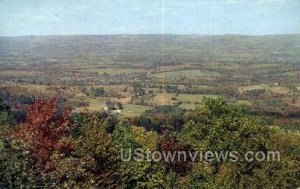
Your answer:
0;34;300;65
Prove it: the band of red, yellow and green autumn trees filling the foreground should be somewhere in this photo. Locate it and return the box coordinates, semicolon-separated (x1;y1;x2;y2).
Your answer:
0;96;300;188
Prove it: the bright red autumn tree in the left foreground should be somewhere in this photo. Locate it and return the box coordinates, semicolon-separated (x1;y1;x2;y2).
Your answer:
15;98;73;167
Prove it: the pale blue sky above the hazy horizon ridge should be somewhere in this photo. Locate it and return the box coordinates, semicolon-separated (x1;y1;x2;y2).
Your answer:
0;0;300;36
